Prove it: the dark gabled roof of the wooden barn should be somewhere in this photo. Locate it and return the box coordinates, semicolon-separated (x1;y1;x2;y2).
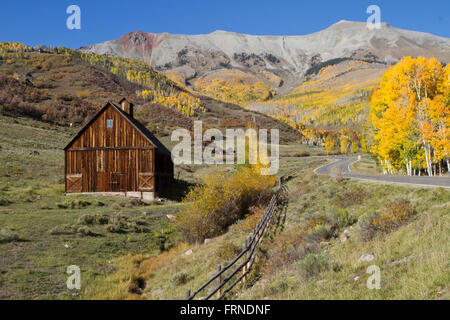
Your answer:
64;99;171;156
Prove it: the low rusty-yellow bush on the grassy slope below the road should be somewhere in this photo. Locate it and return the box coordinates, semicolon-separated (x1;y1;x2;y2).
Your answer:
357;200;415;241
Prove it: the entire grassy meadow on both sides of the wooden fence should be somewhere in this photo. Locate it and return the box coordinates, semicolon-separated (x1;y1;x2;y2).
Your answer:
0;117;450;299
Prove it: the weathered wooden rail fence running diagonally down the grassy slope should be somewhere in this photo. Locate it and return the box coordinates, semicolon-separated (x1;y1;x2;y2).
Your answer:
186;175;287;300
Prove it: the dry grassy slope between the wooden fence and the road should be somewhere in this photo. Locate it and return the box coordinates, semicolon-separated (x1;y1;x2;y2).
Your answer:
237;159;450;299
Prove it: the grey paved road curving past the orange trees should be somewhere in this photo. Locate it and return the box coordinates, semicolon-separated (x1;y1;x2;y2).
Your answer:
314;157;450;189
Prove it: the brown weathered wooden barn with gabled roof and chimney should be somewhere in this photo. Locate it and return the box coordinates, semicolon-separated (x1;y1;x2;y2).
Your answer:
64;99;173;200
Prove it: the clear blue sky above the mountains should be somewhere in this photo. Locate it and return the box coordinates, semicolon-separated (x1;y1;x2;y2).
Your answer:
0;0;450;48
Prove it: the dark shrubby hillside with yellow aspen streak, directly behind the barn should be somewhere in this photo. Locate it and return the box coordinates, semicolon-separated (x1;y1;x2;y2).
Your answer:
0;43;300;142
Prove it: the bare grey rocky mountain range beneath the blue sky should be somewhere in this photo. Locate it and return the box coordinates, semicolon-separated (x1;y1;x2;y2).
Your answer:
80;20;450;95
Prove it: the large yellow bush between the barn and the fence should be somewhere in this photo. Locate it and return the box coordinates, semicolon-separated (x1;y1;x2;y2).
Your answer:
176;166;275;243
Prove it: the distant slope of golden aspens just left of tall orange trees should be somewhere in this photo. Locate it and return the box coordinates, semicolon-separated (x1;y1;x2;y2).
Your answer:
247;59;388;131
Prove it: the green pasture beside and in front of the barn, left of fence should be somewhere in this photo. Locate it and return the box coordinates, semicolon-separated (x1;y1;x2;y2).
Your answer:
0;117;180;299
